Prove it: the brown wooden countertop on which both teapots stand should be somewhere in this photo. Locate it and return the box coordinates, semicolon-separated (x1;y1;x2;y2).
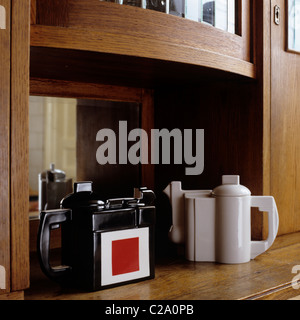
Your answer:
25;233;300;300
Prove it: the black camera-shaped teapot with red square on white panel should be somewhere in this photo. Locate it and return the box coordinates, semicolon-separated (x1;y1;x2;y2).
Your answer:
37;182;155;291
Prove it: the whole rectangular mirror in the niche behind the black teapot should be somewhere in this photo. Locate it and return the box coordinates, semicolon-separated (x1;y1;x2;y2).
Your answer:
29;96;141;216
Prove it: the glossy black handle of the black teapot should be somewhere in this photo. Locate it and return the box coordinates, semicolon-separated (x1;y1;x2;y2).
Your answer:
37;209;71;281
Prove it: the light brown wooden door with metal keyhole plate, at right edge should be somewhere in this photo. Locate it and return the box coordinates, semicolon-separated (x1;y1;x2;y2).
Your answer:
271;0;300;234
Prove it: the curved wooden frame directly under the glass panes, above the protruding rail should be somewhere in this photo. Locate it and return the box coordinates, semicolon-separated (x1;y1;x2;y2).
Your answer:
36;0;250;61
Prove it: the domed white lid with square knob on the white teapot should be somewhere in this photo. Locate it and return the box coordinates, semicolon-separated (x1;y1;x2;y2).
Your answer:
212;175;251;197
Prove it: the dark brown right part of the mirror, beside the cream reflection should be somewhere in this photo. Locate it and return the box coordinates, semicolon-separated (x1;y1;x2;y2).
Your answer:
76;100;140;199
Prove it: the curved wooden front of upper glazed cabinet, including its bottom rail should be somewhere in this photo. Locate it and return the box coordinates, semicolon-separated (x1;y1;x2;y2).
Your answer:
31;0;255;78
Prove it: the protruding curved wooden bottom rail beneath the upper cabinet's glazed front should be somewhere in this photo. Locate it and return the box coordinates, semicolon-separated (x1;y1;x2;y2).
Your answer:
31;25;255;78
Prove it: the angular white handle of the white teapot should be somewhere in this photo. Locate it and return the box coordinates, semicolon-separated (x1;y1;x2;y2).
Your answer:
251;196;279;259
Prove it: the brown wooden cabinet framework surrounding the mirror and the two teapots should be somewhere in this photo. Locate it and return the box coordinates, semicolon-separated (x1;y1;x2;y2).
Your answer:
0;0;300;294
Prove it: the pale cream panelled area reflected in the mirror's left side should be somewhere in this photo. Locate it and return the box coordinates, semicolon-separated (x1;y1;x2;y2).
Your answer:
29;96;76;215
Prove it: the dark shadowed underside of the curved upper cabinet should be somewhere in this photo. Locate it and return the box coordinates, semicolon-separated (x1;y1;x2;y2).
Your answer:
30;47;255;88
